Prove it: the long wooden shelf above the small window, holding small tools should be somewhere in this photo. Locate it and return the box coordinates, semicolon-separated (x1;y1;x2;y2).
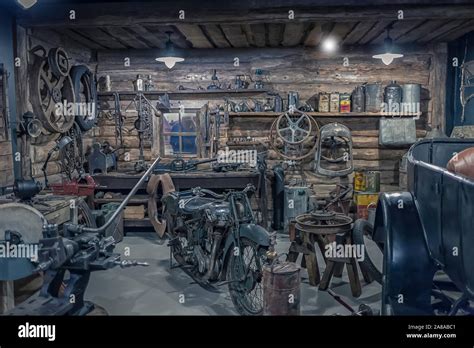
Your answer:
97;88;268;100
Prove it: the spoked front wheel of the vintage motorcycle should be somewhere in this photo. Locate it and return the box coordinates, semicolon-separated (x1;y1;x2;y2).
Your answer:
227;238;266;315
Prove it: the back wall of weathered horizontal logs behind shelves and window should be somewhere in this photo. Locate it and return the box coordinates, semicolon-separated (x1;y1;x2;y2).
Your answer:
98;45;445;198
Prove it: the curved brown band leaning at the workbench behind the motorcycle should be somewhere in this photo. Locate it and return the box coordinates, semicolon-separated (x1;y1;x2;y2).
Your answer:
146;174;176;238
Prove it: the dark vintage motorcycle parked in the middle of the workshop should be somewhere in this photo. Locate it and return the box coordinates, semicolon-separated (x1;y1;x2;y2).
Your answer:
162;185;270;315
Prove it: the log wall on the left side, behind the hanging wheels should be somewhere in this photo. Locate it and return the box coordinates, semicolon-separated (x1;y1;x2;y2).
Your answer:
22;27;95;182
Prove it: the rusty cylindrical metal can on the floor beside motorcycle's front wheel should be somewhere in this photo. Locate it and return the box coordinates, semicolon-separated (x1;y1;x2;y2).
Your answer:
263;262;301;315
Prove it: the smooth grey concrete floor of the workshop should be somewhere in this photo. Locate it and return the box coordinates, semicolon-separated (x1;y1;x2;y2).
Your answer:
86;232;381;315
